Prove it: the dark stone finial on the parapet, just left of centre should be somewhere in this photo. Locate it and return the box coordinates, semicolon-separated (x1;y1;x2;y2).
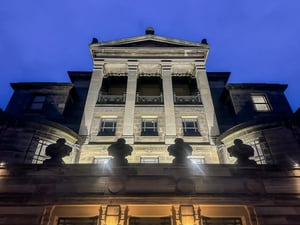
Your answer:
107;138;132;166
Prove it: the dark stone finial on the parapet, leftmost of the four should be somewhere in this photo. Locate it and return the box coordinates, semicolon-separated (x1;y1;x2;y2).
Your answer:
43;138;72;165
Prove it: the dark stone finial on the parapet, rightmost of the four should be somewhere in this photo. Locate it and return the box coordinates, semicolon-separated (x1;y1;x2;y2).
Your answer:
227;139;257;166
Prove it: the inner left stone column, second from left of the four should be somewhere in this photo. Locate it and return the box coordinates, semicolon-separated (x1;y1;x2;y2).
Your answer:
123;65;137;144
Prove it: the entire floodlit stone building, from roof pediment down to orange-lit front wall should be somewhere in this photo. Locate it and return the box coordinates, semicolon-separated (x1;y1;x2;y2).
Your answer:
0;28;300;225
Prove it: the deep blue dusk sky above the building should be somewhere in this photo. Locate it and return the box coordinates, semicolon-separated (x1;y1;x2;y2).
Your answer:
0;0;300;111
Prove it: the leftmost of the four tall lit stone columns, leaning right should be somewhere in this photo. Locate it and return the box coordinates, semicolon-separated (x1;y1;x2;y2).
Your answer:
79;66;103;143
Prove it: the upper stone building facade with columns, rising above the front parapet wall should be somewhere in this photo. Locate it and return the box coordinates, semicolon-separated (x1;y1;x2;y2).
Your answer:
1;29;300;164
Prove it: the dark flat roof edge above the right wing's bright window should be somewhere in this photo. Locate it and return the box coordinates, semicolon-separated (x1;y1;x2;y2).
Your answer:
226;83;288;91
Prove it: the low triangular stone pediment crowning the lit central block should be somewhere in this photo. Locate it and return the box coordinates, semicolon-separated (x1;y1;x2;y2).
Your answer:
91;35;209;48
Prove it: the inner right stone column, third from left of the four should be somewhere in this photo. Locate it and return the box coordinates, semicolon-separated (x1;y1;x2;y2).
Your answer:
162;65;176;144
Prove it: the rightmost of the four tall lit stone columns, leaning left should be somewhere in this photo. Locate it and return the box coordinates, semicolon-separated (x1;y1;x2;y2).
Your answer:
196;65;220;145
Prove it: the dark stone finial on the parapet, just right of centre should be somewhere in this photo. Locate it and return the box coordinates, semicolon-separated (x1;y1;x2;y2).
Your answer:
168;138;193;165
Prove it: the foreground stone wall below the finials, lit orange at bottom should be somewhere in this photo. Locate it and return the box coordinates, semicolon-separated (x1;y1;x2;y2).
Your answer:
0;164;300;225
